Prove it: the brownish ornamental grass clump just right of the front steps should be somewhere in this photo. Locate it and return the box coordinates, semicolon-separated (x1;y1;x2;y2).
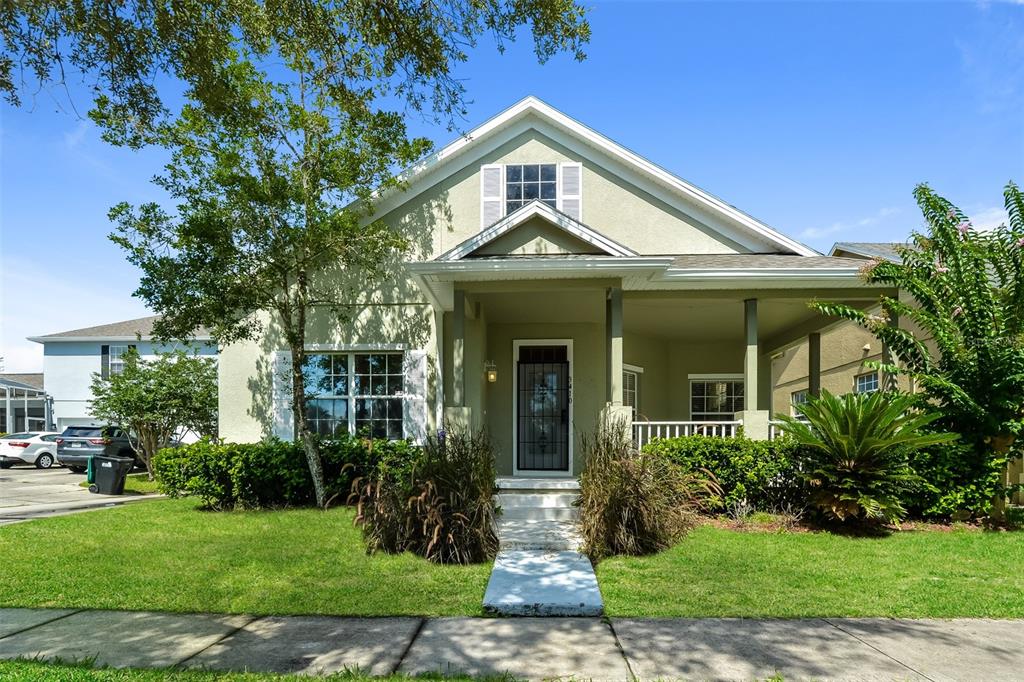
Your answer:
577;424;707;561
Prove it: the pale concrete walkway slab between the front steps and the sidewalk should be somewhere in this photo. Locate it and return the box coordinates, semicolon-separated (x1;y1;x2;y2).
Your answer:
483;550;604;615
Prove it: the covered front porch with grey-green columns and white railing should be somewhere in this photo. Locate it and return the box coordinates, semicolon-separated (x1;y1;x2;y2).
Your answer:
411;259;892;477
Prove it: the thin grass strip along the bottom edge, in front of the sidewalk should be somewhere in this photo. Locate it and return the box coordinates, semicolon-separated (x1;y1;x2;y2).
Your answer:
0;660;512;682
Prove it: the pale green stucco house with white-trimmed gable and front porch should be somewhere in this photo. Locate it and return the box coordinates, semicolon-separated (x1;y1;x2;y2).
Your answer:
219;97;889;476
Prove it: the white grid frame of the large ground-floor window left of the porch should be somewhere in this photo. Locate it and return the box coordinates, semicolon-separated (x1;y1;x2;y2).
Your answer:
303;348;408;440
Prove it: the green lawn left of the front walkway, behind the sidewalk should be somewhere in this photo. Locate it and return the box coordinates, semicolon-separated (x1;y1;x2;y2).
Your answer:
0;500;490;615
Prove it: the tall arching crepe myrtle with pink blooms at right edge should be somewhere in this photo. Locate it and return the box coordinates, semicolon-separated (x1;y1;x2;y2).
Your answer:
812;182;1024;509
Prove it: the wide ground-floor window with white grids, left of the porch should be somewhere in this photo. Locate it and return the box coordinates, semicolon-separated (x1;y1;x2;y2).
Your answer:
303;352;404;440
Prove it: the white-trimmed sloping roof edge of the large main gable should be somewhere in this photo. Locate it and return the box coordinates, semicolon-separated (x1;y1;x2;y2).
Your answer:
377;96;820;256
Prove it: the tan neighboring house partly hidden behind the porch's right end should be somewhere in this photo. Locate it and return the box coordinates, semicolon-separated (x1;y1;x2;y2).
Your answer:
772;242;914;415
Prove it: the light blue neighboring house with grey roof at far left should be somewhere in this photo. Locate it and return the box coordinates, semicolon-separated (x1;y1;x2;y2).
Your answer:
29;315;217;431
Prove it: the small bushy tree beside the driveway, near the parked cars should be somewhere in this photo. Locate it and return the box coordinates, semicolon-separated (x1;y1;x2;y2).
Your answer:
89;348;217;480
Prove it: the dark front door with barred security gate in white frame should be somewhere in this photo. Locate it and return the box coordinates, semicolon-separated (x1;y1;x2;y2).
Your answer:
516;344;571;473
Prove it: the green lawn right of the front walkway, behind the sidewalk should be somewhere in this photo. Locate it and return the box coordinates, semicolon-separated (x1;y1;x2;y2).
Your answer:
597;525;1024;617
